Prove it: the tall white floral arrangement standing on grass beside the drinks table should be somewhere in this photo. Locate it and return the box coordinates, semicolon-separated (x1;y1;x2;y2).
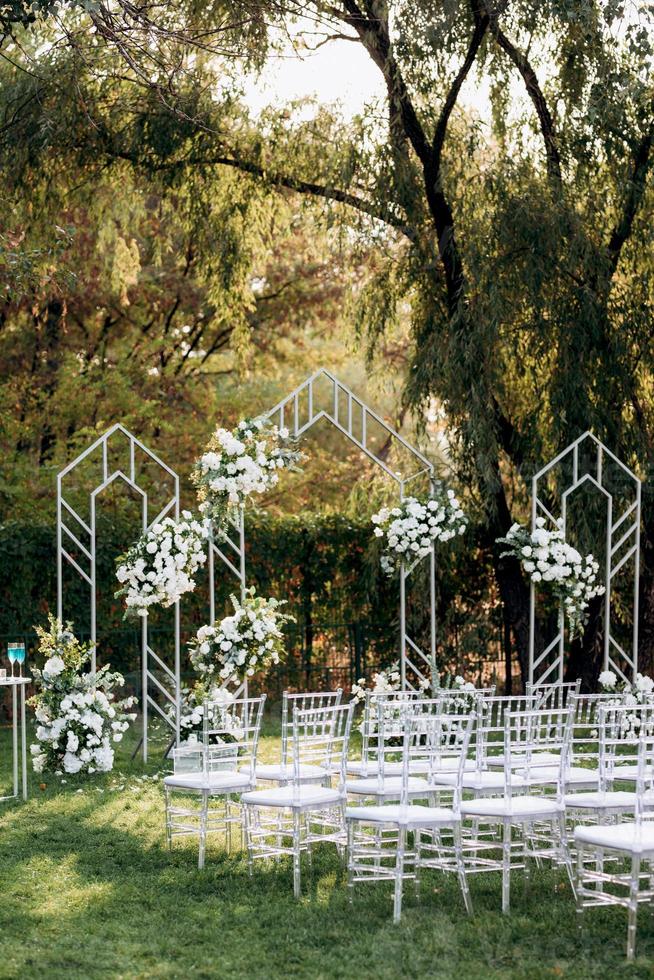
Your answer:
29;616;136;776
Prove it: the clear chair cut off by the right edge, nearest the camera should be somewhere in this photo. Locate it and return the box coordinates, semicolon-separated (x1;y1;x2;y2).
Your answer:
574;732;654;960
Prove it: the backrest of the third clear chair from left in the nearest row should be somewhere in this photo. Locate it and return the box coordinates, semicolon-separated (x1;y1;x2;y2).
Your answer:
400;702;477;813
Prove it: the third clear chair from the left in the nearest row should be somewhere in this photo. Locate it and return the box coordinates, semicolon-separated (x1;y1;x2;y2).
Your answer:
346;699;475;922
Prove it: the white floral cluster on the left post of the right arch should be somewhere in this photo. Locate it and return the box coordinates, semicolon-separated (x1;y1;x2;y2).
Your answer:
497;517;604;639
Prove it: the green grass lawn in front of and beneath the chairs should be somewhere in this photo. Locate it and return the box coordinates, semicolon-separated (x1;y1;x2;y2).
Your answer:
0;716;654;980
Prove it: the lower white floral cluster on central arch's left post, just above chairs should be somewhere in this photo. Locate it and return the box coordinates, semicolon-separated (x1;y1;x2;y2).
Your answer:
189;588;294;684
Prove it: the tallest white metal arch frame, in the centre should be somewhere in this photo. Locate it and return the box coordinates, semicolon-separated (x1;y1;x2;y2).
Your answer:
209;368;436;688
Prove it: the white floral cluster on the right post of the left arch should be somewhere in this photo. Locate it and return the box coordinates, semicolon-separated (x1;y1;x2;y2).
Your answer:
115;510;209;616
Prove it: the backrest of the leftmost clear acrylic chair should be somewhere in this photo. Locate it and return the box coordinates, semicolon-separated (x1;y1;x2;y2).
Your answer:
202;692;266;778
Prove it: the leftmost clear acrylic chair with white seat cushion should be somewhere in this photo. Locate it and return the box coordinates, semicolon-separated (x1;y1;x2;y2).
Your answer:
164;694;266;868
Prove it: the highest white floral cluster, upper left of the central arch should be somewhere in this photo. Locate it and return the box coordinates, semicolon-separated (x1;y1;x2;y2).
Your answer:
191;418;303;529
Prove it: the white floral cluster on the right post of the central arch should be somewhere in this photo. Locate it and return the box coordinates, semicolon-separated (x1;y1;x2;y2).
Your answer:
372;483;467;575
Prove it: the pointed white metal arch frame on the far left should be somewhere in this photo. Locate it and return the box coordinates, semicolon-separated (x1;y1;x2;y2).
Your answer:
57;424;181;761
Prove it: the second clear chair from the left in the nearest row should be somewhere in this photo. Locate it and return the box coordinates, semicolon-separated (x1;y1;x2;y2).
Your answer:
241;704;354;898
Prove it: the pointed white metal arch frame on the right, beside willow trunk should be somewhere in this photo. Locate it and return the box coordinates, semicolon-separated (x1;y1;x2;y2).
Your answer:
529;432;641;686
